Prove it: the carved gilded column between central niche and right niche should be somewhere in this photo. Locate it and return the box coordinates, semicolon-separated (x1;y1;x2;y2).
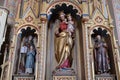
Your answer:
82;17;93;80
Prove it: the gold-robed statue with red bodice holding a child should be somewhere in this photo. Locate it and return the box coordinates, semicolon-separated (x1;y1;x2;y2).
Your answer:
55;11;74;69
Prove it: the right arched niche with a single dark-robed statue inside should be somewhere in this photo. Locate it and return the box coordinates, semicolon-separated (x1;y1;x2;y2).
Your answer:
91;28;115;75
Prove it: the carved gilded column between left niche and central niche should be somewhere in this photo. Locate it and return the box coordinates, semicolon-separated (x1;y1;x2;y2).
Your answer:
38;15;47;80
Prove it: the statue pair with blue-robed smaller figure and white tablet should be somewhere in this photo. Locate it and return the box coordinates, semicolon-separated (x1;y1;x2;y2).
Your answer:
18;35;37;74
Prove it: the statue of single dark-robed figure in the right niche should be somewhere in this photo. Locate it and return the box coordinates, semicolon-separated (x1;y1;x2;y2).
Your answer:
94;35;110;74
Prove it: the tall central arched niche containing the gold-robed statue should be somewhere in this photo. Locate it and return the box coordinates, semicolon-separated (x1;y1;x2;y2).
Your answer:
46;4;84;80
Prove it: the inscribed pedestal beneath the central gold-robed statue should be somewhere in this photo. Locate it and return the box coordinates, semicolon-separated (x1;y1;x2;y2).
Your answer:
53;69;76;80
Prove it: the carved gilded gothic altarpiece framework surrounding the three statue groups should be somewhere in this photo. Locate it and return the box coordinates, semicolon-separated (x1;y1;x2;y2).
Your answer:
1;0;120;80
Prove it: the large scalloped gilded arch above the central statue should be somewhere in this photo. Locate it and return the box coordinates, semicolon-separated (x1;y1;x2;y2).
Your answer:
46;1;82;16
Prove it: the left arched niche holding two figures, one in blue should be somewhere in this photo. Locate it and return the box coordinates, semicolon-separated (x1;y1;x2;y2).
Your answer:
16;27;37;75
